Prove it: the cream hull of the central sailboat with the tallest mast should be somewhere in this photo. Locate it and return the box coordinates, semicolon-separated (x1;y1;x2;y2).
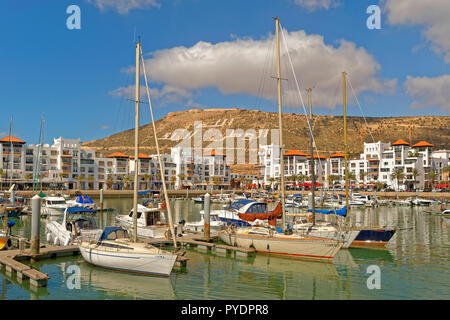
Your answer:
219;228;342;261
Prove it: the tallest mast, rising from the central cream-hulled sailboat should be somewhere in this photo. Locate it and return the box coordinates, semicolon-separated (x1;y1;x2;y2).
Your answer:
275;17;286;232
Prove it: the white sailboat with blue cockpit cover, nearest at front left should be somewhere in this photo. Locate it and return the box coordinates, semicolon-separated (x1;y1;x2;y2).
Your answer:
79;41;178;277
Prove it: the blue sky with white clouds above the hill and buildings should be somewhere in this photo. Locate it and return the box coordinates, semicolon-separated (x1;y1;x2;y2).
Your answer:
0;0;450;144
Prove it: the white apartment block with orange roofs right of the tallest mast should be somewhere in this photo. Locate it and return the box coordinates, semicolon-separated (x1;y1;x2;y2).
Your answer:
259;139;450;190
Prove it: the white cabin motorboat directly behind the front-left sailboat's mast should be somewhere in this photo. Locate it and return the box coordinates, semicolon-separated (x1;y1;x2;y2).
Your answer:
116;204;181;239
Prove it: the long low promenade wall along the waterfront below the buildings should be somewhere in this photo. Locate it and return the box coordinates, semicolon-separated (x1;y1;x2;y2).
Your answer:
12;189;450;200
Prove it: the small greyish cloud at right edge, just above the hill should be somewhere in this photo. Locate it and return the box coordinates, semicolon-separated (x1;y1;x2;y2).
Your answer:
405;74;450;112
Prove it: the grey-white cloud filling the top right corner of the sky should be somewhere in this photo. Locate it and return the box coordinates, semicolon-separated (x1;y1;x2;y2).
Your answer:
385;0;450;63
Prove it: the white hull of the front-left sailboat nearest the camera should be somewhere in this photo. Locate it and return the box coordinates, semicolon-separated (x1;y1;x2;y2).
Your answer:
79;242;177;277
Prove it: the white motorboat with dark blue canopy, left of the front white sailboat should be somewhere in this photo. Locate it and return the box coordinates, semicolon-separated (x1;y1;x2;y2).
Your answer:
45;207;103;246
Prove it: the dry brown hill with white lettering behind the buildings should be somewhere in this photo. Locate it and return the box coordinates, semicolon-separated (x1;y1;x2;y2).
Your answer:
83;108;450;172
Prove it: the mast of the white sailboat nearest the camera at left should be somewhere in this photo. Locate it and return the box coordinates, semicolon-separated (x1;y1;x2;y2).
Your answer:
133;42;141;242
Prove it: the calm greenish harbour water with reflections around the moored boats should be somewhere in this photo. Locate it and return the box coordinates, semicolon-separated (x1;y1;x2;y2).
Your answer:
0;198;450;300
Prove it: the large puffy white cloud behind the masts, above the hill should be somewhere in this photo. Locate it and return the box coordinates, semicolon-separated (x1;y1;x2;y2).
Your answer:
129;31;396;108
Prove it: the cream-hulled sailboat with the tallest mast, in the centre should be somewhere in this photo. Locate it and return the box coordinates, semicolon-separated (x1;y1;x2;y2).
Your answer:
219;18;343;261
